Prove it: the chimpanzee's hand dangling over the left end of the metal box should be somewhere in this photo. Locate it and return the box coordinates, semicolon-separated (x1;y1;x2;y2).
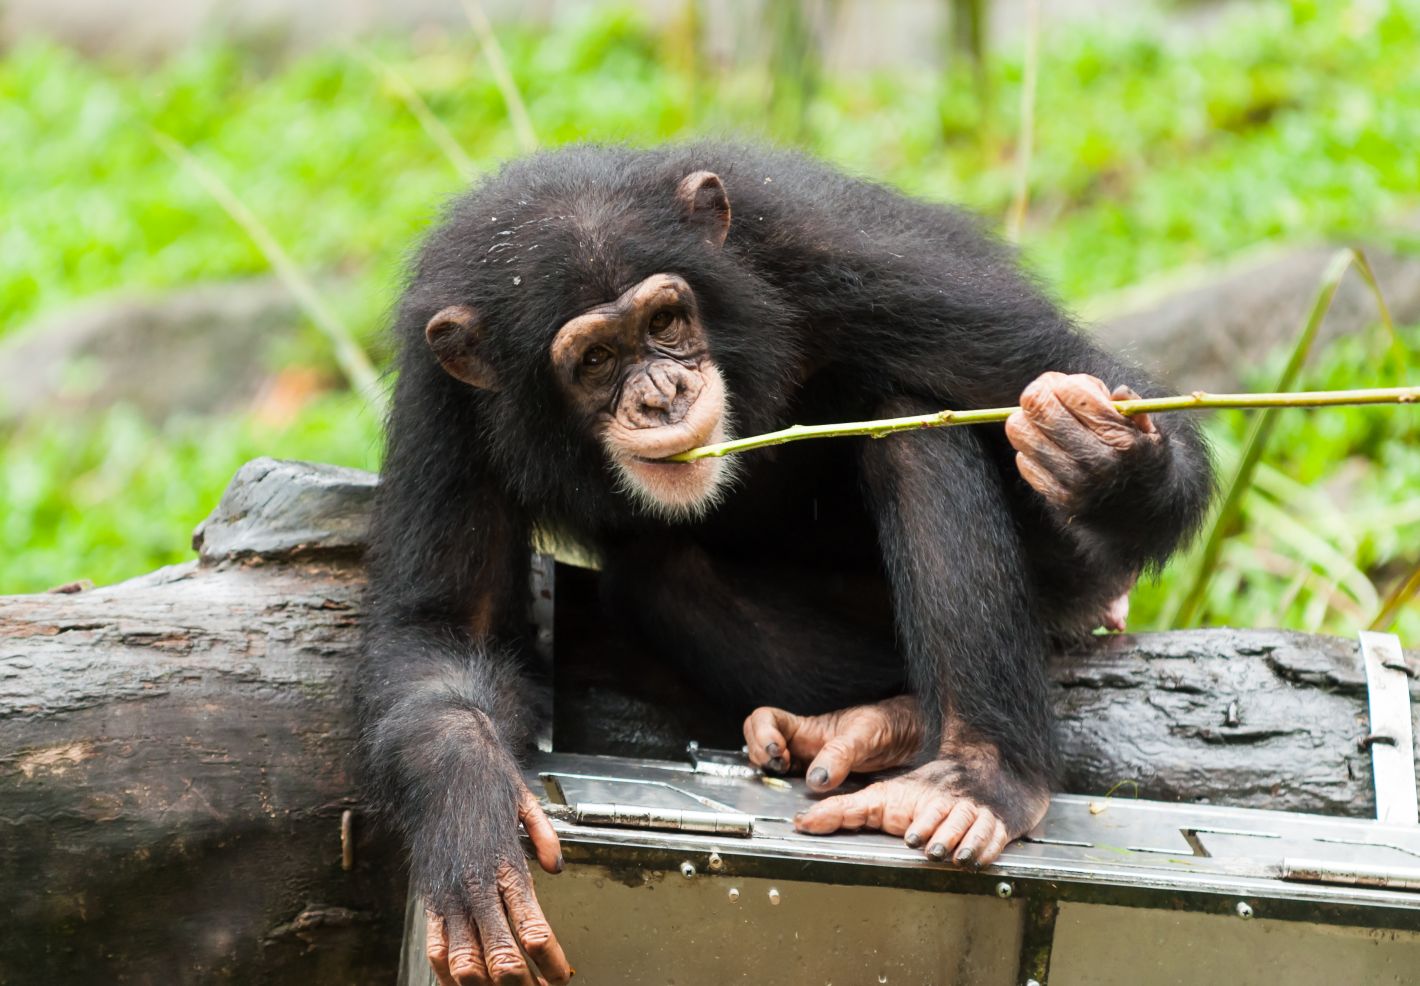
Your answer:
425;777;572;986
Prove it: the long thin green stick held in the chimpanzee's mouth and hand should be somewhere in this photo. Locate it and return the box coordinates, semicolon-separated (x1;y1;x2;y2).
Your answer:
667;386;1420;462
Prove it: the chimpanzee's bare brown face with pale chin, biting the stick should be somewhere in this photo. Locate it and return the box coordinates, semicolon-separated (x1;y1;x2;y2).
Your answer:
551;267;728;519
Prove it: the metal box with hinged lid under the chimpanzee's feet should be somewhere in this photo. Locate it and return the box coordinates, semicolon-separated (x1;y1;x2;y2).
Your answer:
406;753;1420;986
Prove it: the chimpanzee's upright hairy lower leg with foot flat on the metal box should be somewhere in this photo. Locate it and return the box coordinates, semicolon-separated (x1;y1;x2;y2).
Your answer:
801;399;1054;862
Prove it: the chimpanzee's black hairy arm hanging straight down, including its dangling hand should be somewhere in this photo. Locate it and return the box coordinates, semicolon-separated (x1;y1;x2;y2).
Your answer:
359;371;569;982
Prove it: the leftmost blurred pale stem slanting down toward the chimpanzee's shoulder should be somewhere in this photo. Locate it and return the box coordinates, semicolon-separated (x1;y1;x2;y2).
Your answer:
149;129;385;412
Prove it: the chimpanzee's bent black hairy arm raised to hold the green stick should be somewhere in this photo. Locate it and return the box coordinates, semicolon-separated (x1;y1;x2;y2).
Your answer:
802;218;1211;608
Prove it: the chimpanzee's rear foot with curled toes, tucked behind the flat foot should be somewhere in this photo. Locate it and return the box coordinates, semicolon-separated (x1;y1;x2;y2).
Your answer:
744;695;923;791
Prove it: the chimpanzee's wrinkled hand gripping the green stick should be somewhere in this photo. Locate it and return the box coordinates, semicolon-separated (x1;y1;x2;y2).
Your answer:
1005;371;1163;516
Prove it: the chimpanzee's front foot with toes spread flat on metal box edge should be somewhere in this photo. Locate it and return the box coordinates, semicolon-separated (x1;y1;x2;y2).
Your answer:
794;725;1049;869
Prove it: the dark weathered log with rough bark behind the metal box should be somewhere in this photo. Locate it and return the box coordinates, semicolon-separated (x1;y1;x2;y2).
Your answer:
0;459;1420;983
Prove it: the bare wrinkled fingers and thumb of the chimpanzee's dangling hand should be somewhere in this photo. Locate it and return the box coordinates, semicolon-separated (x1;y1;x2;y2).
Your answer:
425;787;574;986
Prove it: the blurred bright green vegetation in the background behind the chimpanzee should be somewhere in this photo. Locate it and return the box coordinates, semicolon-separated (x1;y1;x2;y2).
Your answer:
0;0;1420;639
